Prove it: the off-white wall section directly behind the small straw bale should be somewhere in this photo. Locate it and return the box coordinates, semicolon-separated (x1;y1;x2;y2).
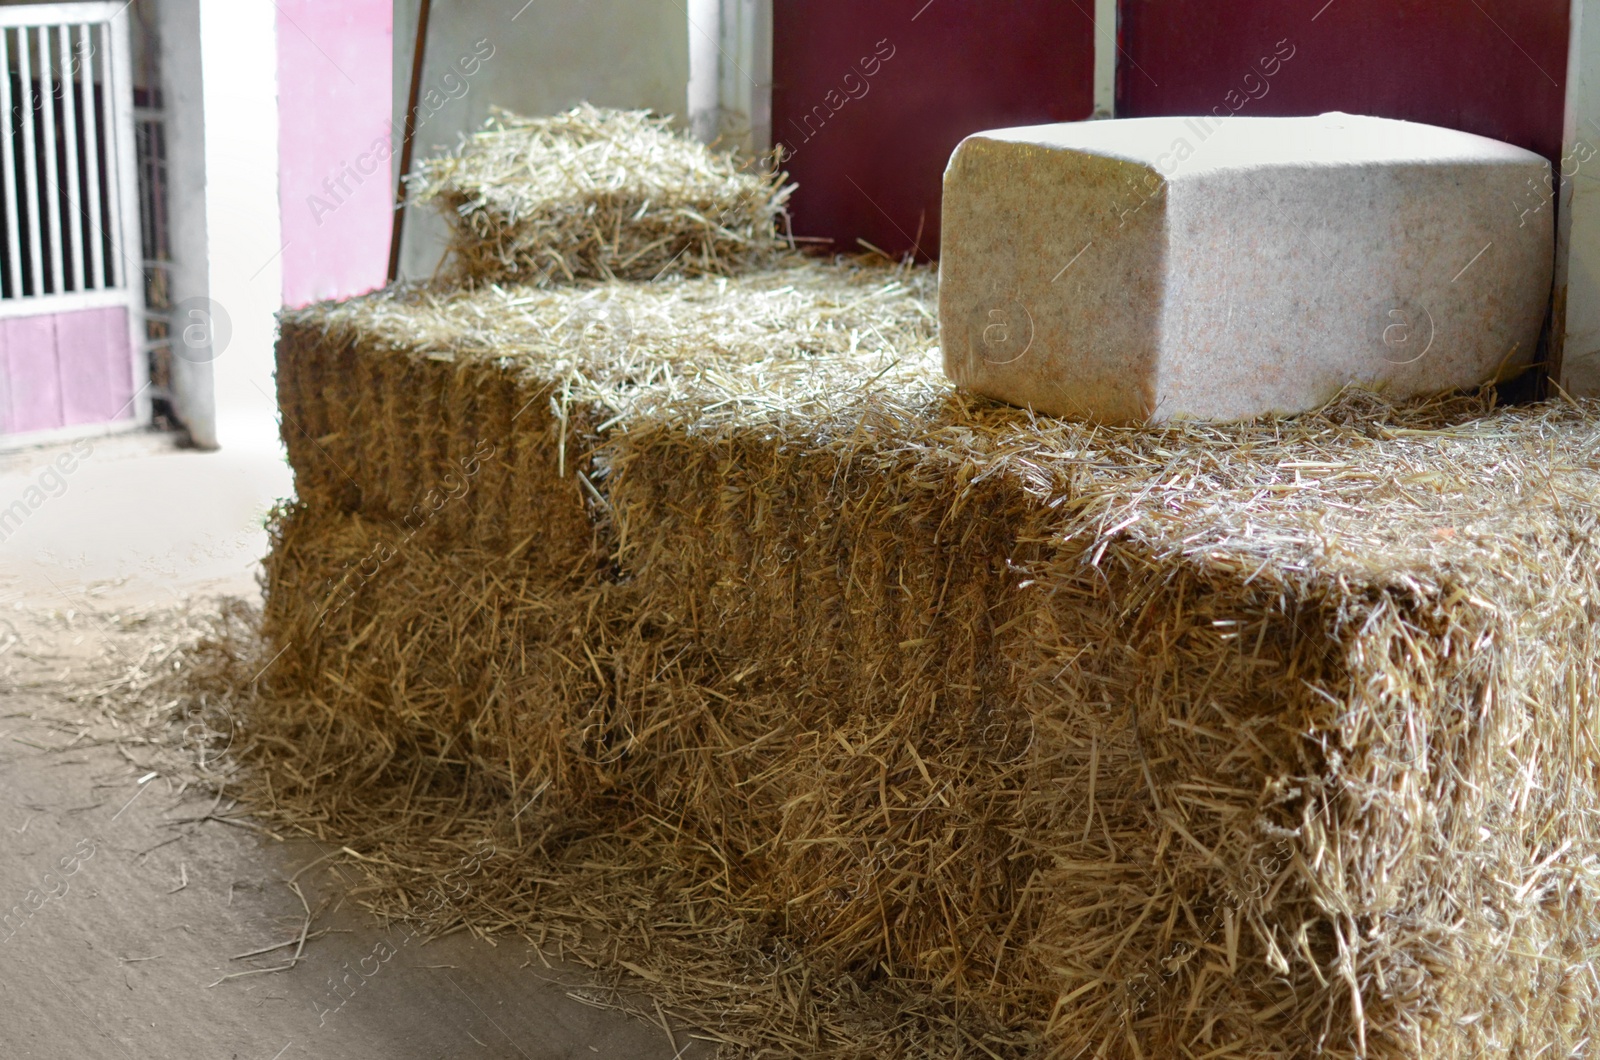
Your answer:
390;0;690;279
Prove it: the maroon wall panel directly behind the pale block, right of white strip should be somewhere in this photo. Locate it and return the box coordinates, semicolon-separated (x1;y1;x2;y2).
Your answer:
1117;0;1570;160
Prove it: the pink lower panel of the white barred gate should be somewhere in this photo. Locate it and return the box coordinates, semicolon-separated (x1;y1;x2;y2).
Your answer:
0;306;133;434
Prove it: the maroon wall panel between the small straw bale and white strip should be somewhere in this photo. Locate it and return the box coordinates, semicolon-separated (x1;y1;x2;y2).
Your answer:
773;0;1094;256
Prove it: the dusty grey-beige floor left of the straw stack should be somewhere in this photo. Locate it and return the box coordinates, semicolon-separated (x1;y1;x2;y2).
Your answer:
0;436;710;1060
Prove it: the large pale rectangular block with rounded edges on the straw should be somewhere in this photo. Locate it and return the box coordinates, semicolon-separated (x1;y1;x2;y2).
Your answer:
939;114;1554;424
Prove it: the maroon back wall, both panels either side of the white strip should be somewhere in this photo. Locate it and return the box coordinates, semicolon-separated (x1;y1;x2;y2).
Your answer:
773;0;1568;255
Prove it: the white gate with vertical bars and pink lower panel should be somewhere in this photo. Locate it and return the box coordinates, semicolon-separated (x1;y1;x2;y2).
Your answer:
0;3;147;447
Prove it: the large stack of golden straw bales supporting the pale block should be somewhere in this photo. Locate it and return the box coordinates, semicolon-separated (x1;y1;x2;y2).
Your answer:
268;264;1600;1060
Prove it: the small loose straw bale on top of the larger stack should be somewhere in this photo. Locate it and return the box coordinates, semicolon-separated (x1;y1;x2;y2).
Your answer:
413;104;794;285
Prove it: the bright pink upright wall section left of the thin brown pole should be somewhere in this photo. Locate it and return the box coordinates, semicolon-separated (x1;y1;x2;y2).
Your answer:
277;0;394;306
